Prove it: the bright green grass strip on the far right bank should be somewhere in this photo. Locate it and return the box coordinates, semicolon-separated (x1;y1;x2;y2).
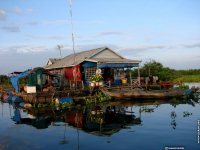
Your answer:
174;74;200;82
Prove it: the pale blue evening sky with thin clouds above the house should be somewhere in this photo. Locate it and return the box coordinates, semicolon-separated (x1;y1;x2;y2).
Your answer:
0;0;200;74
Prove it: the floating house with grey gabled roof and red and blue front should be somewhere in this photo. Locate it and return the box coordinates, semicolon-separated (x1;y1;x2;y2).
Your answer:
44;47;141;84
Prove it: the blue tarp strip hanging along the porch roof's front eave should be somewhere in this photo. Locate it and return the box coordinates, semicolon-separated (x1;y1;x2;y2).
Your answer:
97;63;139;68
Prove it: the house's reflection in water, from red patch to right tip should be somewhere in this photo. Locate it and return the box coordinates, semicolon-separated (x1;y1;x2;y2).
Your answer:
66;106;141;135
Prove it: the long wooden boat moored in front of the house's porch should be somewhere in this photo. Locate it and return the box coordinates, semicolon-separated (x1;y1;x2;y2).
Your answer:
100;88;186;99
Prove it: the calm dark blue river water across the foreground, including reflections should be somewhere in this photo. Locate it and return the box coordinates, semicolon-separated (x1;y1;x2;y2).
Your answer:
0;84;200;150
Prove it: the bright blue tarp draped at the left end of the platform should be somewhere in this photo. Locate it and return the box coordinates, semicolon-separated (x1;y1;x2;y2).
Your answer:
10;70;30;93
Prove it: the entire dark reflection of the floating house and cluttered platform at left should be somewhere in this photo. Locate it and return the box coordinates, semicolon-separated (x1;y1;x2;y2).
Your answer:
13;106;141;135
